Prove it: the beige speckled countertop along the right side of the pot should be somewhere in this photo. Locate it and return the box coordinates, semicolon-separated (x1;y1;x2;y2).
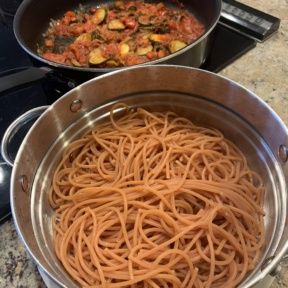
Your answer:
219;0;288;288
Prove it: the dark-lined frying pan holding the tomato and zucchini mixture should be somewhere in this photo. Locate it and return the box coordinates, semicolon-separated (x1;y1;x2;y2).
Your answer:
13;0;221;73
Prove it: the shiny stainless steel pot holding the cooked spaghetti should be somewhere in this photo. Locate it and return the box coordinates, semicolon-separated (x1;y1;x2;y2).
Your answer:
2;65;288;288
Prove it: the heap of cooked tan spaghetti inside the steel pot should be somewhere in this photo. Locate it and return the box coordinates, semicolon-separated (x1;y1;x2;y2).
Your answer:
49;104;264;288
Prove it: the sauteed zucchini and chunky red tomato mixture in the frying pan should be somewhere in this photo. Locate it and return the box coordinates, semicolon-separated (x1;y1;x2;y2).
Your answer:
38;1;205;67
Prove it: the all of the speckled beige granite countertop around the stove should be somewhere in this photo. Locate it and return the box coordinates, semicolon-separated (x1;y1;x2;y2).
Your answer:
0;0;288;288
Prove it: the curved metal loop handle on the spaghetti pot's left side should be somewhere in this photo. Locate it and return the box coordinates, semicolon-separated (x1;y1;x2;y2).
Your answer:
1;106;49;167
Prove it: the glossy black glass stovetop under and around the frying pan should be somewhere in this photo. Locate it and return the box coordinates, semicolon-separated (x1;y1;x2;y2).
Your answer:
0;0;280;223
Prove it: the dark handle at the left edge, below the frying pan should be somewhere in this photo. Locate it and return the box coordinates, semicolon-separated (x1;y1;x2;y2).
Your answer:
0;67;53;93
